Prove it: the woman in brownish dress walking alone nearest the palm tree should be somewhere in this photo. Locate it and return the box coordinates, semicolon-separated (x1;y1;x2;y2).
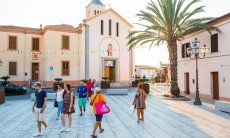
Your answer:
133;84;146;123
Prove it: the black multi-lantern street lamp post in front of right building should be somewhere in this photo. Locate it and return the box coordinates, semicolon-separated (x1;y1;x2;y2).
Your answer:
187;38;208;105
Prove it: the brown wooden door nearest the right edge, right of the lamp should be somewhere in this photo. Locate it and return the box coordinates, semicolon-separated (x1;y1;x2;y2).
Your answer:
212;72;219;100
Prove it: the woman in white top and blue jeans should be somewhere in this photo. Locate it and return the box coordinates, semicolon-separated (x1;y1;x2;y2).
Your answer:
56;84;64;120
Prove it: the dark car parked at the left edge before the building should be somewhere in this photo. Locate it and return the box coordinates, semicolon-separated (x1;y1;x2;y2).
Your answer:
0;80;27;94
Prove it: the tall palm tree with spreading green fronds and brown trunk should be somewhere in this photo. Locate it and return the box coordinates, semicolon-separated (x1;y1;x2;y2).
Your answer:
128;0;218;96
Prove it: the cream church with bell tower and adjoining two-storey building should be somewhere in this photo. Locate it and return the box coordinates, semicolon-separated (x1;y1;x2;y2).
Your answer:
0;0;134;86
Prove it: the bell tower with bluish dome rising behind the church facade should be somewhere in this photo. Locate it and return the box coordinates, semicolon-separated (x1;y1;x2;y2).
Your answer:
86;0;105;19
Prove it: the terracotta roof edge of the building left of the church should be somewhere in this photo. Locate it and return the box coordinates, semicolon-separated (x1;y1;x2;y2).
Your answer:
0;24;82;35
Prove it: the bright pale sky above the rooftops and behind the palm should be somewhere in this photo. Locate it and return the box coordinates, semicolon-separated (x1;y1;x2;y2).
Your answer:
0;0;230;66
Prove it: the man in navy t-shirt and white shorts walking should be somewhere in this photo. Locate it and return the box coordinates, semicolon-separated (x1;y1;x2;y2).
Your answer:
32;83;47;137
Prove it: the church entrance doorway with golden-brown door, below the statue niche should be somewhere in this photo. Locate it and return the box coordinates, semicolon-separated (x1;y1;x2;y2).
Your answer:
104;60;115;82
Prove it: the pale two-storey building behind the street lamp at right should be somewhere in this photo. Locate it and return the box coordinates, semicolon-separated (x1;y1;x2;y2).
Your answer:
178;13;230;101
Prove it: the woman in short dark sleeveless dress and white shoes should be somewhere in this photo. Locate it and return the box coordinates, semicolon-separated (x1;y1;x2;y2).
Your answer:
60;84;75;132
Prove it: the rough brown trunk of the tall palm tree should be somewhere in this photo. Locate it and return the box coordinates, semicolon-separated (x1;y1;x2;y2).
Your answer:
168;41;180;97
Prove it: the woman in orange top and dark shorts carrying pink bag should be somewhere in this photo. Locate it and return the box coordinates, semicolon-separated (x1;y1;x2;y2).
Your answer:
90;87;106;138
